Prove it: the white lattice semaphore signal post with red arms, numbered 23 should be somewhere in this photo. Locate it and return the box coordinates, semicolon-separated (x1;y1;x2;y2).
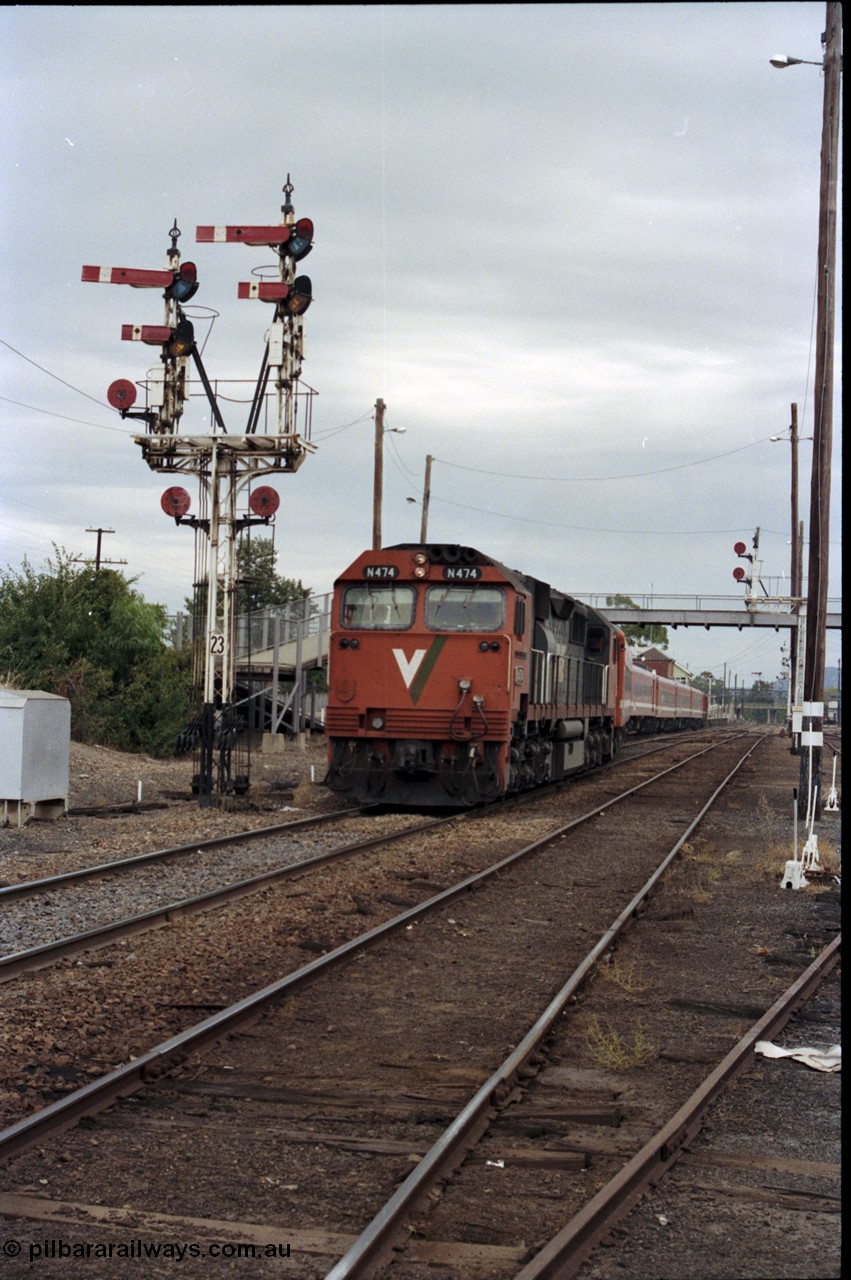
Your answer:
82;175;316;806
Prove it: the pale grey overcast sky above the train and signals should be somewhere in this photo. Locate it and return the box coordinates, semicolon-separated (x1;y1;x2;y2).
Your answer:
0;3;841;684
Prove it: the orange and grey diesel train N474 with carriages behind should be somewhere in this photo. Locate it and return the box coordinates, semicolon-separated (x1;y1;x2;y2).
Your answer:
325;543;708;808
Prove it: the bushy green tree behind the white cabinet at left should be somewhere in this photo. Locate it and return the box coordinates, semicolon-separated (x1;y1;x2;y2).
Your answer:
0;548;189;754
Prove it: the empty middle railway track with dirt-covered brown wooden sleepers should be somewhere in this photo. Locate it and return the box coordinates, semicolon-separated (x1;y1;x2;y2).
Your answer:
4;727;834;1275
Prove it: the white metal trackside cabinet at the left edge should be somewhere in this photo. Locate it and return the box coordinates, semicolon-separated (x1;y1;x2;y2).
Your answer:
0;689;70;827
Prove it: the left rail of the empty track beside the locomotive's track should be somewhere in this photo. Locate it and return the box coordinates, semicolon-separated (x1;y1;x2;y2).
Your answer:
0;742;759;1162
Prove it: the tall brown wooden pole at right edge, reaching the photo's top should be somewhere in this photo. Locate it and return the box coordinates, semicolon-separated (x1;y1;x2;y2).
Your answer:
799;0;842;817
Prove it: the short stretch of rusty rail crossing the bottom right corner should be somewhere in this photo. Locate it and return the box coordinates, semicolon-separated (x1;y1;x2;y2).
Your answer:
514;934;842;1280
